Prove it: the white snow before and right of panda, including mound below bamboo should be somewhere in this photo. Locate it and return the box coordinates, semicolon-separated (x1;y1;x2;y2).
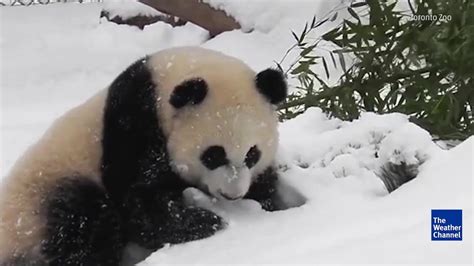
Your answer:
140;108;474;265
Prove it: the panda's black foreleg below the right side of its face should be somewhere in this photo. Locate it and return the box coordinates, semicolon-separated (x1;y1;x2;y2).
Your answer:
244;167;284;211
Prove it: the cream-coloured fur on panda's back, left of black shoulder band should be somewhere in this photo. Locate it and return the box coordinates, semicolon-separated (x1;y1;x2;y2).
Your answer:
0;91;105;261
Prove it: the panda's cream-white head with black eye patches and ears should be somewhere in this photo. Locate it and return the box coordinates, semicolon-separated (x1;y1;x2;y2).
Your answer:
150;49;287;199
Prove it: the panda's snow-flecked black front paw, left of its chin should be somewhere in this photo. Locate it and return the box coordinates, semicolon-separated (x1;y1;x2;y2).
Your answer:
182;207;225;240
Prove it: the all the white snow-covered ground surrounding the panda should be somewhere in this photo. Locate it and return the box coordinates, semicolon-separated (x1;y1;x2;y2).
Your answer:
0;0;474;265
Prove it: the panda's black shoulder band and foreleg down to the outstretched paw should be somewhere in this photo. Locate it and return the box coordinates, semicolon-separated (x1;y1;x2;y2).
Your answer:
102;59;222;252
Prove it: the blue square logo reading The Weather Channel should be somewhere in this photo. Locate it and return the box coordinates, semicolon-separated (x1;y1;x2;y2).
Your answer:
431;210;462;241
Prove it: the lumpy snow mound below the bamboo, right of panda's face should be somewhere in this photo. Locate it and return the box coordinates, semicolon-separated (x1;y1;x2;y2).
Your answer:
278;108;439;177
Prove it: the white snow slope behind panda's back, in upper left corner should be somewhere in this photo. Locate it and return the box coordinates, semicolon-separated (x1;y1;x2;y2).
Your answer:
0;4;208;176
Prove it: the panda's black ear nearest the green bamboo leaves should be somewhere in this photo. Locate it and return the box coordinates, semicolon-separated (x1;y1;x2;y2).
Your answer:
255;68;288;104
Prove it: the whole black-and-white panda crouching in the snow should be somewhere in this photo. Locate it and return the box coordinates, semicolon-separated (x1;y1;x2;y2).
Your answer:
0;47;287;265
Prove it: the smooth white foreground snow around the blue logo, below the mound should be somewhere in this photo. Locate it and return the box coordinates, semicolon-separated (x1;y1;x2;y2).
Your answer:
146;134;474;265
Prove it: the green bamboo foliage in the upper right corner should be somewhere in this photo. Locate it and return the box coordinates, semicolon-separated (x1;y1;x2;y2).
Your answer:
279;0;474;139
